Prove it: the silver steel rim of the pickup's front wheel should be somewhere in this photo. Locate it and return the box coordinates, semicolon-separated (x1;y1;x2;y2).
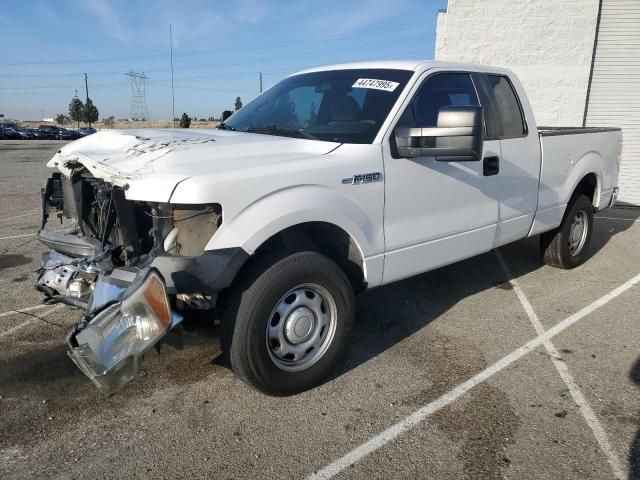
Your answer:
267;283;337;372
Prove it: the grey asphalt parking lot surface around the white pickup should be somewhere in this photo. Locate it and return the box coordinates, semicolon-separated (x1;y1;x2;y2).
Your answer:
0;141;640;479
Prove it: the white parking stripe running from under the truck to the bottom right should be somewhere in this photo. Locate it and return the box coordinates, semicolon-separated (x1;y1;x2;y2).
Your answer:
495;250;625;480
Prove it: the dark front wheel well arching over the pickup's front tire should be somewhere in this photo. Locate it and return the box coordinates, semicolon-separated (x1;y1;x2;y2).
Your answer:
254;222;366;293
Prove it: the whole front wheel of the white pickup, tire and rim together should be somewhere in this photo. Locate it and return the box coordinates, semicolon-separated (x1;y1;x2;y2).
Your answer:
222;252;355;395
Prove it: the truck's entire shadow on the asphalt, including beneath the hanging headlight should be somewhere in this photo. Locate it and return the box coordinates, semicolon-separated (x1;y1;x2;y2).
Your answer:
0;209;640;408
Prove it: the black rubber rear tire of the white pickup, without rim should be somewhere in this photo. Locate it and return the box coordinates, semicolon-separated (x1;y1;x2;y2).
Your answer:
540;195;593;270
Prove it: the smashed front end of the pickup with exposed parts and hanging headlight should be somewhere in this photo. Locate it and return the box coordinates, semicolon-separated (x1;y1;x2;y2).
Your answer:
36;162;232;394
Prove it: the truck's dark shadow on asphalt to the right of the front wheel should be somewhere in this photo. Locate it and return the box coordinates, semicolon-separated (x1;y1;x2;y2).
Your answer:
334;209;640;378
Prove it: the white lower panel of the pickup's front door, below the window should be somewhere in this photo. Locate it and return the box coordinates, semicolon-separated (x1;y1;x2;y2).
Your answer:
384;141;500;283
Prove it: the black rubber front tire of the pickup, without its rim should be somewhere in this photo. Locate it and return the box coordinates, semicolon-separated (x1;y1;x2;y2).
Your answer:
221;252;355;396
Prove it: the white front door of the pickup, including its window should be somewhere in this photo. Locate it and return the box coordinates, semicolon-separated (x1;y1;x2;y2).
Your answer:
383;71;501;283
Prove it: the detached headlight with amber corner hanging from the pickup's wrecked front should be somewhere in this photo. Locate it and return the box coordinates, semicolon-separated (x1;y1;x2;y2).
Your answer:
69;271;171;394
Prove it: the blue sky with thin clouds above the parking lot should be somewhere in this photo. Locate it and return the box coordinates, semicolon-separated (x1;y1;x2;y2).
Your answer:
0;0;447;120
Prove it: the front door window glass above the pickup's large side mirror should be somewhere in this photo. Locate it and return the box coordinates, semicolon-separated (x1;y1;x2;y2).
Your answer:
399;73;480;127
